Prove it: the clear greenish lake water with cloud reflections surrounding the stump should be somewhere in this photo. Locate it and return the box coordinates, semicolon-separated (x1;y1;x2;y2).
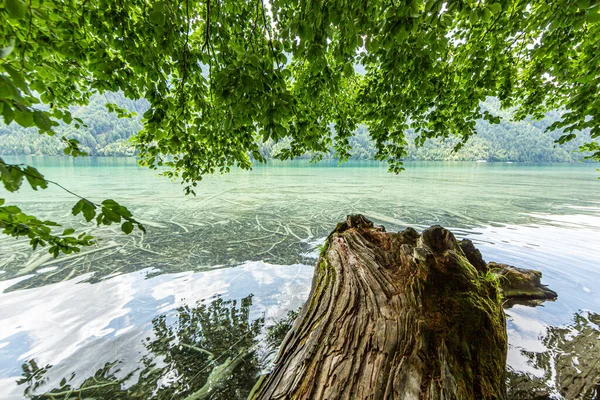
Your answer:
0;157;600;399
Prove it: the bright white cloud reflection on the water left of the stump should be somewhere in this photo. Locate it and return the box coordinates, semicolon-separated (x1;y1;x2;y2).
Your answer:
0;262;313;399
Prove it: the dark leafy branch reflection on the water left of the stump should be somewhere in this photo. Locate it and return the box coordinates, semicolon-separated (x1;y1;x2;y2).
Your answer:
17;295;297;400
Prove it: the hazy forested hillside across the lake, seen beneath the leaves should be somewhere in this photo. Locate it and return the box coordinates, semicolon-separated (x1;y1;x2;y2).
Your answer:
0;93;588;162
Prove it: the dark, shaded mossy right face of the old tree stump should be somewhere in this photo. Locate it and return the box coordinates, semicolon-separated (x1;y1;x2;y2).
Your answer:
425;256;507;399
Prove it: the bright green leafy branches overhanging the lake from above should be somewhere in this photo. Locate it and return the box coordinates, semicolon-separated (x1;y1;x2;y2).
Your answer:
0;0;600;254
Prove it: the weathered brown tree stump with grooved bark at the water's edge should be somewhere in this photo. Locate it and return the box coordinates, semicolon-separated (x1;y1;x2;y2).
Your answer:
251;215;555;400
